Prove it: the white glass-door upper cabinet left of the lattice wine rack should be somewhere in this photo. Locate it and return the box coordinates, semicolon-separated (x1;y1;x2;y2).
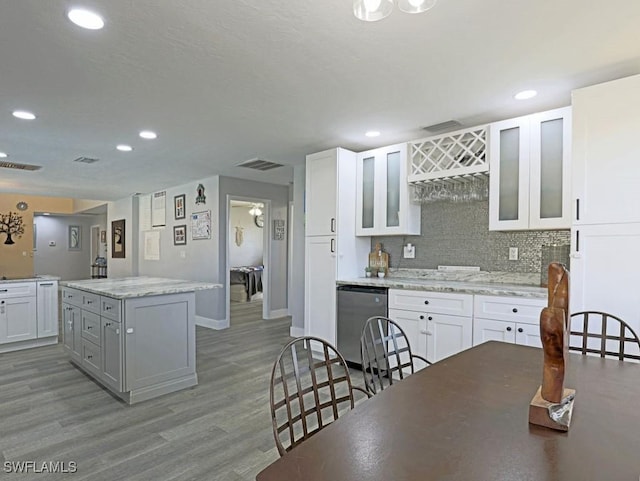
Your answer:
356;144;420;236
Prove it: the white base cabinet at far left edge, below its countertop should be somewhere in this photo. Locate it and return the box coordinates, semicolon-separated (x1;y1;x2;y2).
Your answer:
0;276;58;353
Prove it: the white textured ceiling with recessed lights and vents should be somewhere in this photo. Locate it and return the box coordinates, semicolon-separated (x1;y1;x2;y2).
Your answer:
0;0;640;200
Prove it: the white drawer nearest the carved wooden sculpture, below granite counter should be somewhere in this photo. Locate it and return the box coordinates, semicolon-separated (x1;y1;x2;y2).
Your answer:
473;296;547;324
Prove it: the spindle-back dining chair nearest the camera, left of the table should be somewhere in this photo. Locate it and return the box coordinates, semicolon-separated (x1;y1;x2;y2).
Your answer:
270;336;370;456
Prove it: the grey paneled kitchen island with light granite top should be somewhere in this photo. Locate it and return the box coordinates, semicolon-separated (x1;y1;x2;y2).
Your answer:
60;277;222;404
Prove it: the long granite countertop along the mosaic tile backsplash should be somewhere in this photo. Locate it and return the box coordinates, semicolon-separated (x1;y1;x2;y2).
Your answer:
336;269;547;299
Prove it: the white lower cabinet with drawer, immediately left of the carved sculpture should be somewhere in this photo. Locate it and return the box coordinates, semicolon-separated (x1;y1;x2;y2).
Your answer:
473;296;547;347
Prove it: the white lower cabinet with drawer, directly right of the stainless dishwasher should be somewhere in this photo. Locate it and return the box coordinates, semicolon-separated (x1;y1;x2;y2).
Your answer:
389;289;473;367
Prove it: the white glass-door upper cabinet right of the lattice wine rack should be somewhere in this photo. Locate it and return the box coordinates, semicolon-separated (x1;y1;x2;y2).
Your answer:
489;107;571;230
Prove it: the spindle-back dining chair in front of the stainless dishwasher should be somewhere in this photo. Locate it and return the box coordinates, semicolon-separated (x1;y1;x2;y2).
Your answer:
360;316;431;394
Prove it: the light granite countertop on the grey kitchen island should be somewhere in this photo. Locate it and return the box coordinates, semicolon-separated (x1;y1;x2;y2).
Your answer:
60;276;222;299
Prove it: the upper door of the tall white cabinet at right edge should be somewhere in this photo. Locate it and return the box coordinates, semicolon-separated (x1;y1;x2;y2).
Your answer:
572;75;640;225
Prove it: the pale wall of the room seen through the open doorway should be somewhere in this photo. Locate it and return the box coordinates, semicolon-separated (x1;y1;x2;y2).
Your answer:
228;205;264;267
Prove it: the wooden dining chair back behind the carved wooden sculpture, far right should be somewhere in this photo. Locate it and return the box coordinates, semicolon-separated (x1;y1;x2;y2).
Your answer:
569;311;640;361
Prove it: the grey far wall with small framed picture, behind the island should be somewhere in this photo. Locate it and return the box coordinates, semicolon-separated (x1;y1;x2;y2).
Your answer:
33;215;106;280
